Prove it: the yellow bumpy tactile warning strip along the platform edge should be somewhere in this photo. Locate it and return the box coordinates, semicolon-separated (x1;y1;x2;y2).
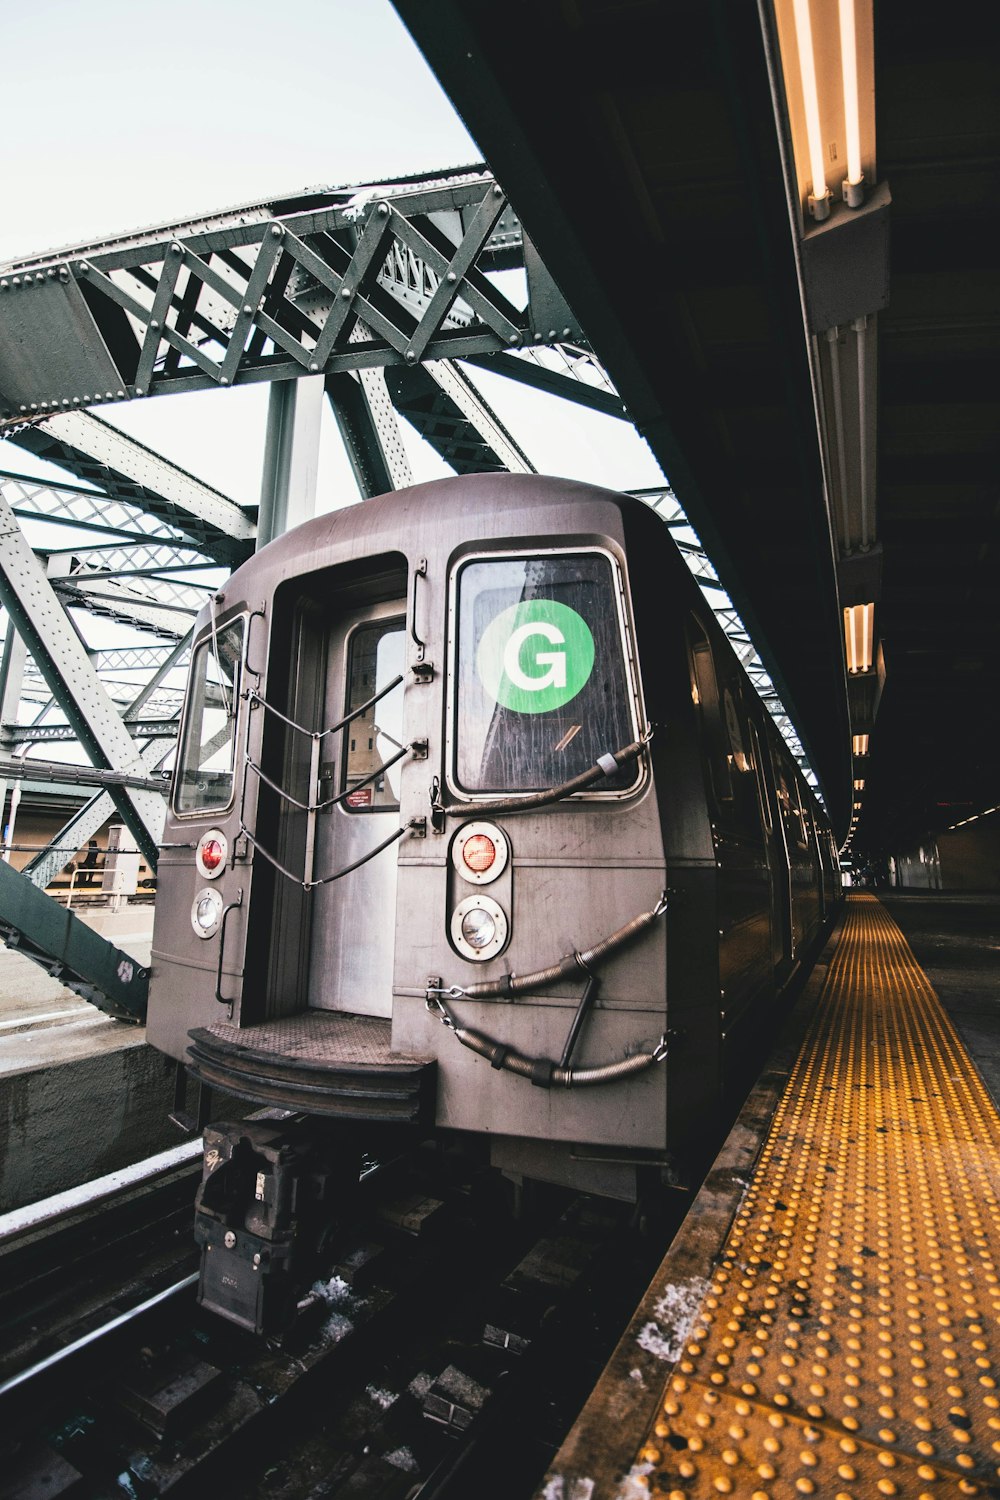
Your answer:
632;894;1000;1500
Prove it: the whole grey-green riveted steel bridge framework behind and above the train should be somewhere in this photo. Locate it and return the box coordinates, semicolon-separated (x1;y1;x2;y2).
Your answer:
0;168;804;990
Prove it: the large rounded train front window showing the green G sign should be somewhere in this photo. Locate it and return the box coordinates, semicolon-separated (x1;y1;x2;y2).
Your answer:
453;552;642;795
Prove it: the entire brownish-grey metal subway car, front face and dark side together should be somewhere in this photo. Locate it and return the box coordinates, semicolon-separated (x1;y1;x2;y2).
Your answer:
148;476;840;1197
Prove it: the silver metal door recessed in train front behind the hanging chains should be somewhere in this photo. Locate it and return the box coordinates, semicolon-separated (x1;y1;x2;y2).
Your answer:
309;599;405;1016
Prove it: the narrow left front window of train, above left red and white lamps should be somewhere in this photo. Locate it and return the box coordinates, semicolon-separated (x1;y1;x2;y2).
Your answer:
174;618;244;813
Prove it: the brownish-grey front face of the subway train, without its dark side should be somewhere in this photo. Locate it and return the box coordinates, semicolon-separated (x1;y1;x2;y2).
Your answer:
148;476;680;1326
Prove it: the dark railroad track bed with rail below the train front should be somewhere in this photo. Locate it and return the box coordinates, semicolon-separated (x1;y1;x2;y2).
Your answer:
0;1154;685;1500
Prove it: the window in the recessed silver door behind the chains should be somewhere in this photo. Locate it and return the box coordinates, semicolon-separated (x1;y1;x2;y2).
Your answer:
340;620;406;813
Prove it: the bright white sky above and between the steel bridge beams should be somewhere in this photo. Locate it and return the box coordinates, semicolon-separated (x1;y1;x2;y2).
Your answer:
0;0;671;510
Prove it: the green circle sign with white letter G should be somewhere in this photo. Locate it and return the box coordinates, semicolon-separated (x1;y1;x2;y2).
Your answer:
475;599;594;714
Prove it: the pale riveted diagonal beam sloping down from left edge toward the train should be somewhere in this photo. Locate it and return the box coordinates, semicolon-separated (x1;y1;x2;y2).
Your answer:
0;497;164;869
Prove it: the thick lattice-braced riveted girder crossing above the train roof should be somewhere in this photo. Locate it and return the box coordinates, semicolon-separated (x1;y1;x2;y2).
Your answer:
0;171;580;426
